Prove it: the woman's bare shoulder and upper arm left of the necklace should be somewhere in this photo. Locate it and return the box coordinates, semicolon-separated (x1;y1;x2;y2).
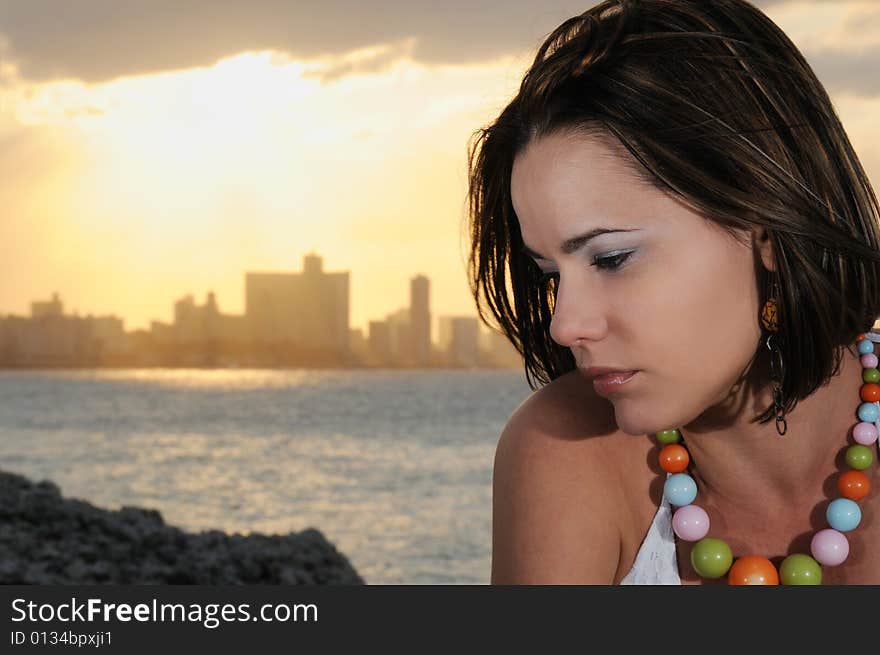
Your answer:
492;371;647;584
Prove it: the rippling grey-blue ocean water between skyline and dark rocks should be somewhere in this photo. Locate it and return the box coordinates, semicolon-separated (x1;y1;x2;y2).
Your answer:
0;369;532;584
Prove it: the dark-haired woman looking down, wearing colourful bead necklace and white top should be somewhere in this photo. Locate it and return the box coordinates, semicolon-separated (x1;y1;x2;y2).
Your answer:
469;0;880;584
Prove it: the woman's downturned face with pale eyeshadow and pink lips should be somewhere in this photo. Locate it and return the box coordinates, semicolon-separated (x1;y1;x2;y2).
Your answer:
511;132;764;434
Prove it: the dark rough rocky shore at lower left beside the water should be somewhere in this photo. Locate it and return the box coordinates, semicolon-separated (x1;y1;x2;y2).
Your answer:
0;471;364;585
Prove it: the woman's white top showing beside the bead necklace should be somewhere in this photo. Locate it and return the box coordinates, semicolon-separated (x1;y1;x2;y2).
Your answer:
620;332;880;585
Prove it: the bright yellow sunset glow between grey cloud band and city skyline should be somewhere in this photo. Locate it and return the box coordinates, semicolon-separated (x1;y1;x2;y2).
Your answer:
0;46;523;329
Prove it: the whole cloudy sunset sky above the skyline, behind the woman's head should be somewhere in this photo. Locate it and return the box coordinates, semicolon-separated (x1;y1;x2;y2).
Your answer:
0;0;880;330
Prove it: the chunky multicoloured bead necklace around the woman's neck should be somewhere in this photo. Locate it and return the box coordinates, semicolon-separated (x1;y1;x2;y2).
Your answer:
655;332;880;585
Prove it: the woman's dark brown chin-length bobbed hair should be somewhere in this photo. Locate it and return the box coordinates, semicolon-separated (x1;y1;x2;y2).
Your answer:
468;0;880;422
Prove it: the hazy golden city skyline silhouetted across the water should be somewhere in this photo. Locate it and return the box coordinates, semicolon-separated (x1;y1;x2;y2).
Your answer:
0;252;521;368
